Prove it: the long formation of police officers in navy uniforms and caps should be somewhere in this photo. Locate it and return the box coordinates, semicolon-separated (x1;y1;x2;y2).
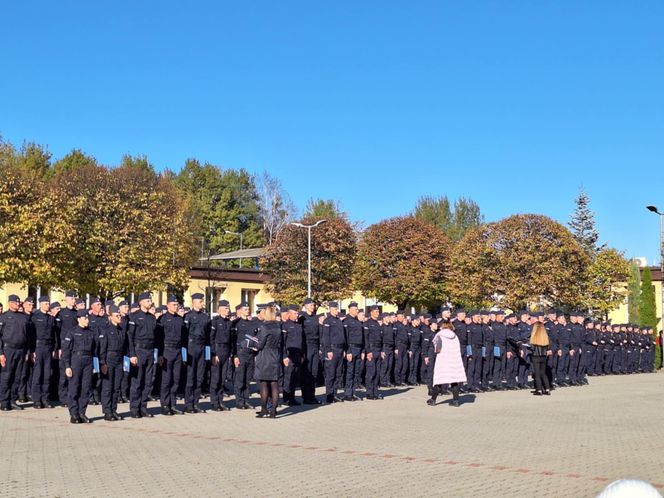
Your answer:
0;291;655;423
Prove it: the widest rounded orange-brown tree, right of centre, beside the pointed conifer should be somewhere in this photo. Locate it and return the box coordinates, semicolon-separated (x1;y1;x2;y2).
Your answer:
448;214;590;309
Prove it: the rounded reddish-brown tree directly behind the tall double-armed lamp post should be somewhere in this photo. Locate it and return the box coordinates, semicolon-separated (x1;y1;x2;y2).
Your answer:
261;218;356;304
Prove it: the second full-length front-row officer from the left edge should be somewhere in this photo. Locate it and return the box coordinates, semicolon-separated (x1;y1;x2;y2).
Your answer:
30;296;55;409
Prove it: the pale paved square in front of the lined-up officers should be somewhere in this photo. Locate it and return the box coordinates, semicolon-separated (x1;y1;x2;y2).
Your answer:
0;373;664;497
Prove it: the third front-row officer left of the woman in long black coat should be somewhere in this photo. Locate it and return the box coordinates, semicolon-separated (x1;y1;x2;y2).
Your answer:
184;292;210;413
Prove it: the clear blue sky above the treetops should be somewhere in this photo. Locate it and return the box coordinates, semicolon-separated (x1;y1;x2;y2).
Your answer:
0;0;664;264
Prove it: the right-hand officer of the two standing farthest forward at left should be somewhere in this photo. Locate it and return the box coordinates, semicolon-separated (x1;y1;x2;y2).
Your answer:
99;304;127;421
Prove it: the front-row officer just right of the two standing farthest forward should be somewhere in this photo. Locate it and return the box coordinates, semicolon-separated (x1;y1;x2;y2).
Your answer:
127;292;157;418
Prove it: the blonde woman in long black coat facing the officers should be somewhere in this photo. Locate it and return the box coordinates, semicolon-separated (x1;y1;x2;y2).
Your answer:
254;306;288;418
